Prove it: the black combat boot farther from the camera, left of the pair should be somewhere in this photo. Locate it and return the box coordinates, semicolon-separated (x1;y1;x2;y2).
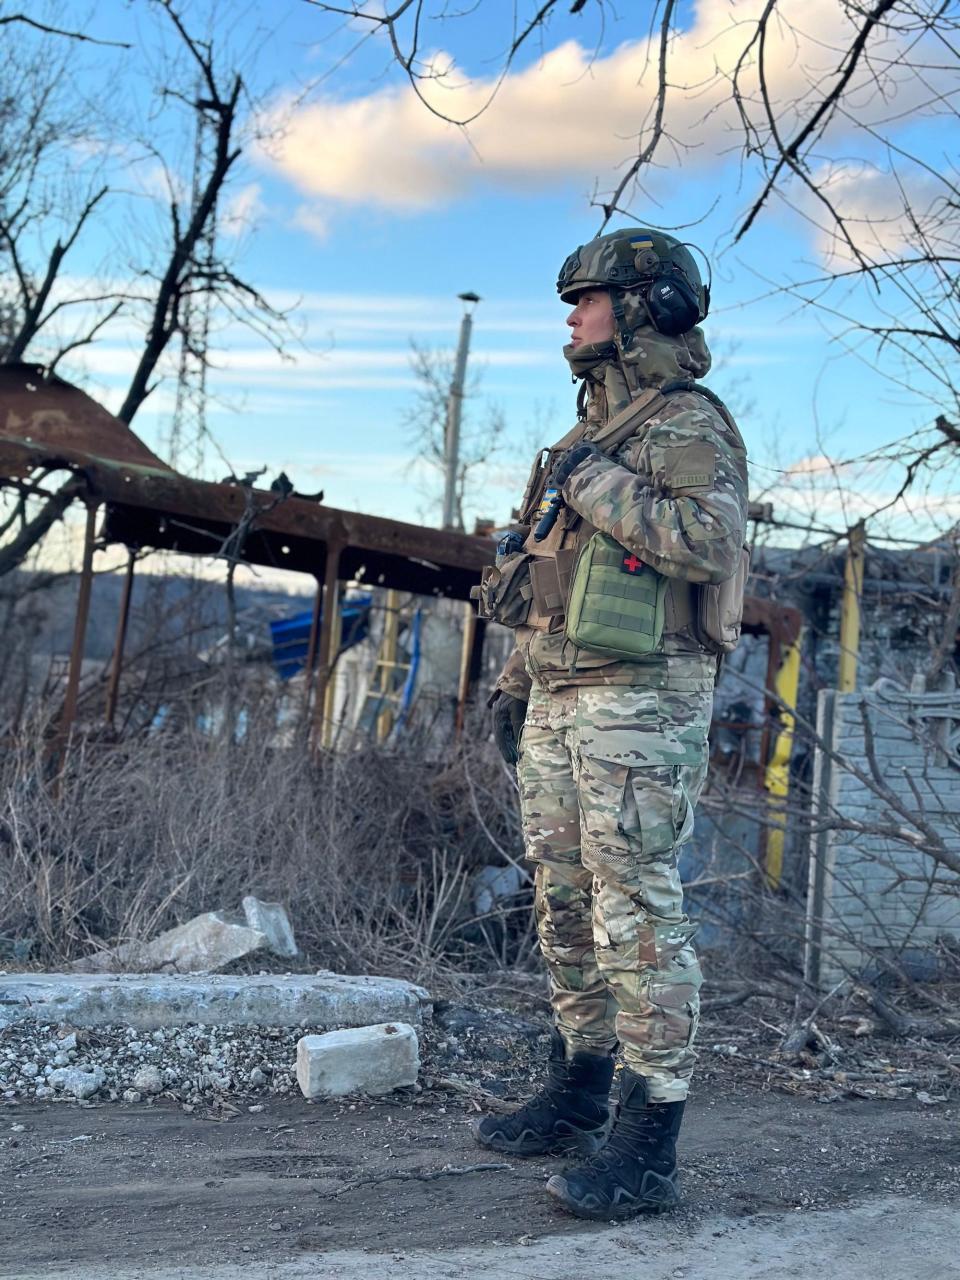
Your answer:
471;1032;613;1156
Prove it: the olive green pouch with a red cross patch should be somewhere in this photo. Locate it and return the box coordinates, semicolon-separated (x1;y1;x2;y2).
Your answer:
566;534;668;660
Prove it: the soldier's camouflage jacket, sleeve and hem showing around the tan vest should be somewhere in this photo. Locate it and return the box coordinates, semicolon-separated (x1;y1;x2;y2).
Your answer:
497;330;748;699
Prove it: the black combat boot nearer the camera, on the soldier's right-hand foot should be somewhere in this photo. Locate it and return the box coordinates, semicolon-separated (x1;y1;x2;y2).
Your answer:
547;1068;684;1221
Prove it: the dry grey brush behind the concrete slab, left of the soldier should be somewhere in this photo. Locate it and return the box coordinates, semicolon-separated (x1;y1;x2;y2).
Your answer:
0;712;532;980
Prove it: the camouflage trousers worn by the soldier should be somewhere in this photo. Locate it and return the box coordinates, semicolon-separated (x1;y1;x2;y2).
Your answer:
517;685;713;1102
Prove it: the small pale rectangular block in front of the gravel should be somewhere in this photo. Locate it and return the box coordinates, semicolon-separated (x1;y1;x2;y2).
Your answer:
297;1023;420;1098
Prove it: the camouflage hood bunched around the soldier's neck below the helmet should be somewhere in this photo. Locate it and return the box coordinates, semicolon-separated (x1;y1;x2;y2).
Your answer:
563;320;710;421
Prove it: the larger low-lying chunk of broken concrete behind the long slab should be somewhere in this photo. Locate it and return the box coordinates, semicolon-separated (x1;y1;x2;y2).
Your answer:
70;911;268;973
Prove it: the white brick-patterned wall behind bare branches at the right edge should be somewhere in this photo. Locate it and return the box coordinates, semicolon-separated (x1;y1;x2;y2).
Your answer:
806;682;960;988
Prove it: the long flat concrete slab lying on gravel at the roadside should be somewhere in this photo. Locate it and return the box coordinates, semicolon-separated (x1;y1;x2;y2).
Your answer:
0;973;431;1030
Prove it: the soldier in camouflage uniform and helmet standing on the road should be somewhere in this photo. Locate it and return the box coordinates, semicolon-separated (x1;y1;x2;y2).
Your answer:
474;228;748;1219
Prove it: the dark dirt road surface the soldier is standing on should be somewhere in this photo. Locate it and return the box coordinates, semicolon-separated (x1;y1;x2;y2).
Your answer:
0;1085;960;1280
